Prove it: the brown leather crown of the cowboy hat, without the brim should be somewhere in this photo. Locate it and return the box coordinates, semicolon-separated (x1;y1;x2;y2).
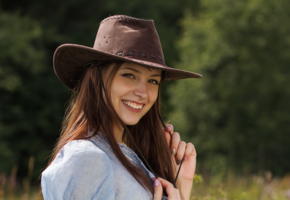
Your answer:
93;15;165;65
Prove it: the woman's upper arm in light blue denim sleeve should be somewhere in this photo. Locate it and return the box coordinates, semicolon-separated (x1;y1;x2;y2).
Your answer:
41;140;115;200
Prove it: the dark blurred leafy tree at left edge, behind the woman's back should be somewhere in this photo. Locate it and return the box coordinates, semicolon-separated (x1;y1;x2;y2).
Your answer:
0;12;65;180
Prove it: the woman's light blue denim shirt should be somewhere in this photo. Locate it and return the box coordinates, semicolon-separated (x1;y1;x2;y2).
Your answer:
41;135;160;200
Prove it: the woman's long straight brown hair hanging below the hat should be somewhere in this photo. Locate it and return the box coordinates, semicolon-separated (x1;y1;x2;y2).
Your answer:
49;61;174;193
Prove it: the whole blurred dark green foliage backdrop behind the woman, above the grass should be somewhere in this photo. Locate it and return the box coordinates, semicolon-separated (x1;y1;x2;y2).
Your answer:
0;0;290;184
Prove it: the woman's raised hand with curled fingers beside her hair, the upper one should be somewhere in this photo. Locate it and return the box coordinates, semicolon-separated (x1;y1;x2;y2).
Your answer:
164;124;196;199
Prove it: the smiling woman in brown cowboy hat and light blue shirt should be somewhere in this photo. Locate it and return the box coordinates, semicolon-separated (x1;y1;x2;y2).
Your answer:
41;15;201;200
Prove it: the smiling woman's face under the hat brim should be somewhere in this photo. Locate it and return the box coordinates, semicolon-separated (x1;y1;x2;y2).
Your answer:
104;62;161;125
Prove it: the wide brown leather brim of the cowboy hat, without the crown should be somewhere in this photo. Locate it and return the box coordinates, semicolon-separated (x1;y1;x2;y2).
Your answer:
53;44;202;89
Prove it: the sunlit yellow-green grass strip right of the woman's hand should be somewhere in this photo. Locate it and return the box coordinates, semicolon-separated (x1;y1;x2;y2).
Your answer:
191;173;290;200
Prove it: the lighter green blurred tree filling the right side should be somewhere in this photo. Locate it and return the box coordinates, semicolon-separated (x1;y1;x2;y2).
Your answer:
171;0;290;174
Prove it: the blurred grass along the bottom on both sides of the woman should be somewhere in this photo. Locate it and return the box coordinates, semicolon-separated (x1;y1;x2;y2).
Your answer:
0;170;290;200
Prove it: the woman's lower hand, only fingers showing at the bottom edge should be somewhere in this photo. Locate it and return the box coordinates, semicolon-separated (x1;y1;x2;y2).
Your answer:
153;178;181;200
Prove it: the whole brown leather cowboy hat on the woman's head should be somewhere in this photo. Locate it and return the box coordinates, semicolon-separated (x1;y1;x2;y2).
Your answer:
53;15;202;89
